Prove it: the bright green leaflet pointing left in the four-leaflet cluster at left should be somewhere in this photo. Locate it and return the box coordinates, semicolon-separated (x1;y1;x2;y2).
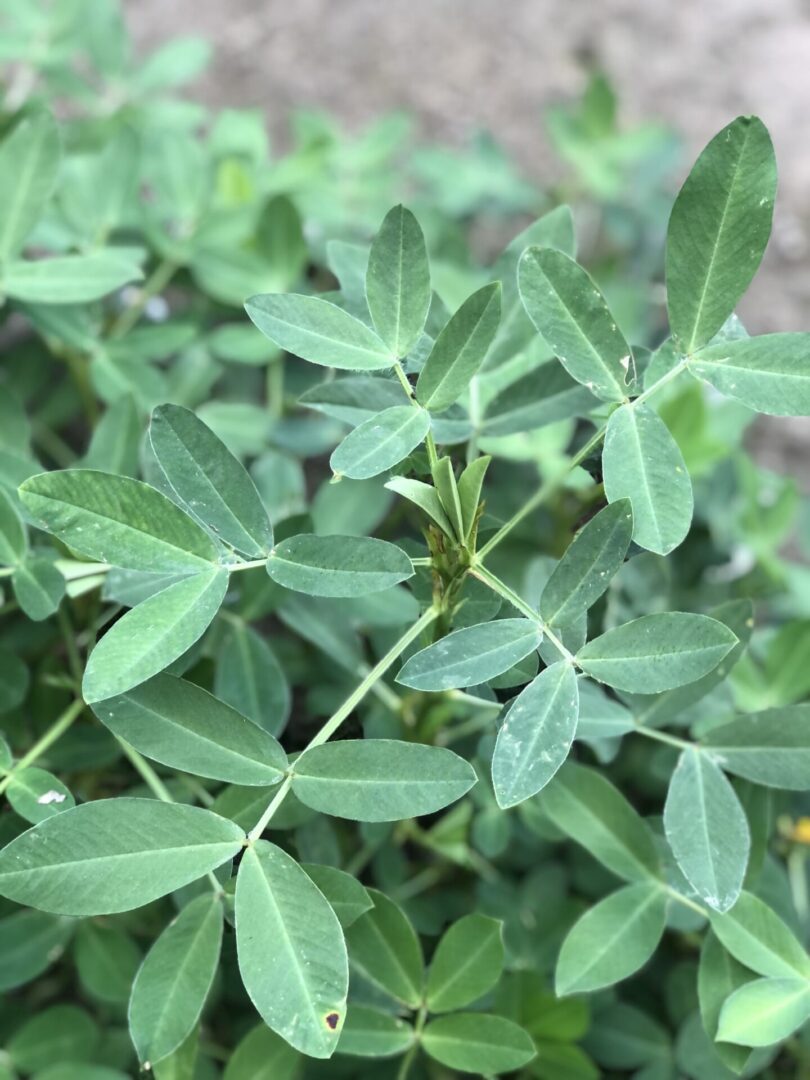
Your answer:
19;469;217;573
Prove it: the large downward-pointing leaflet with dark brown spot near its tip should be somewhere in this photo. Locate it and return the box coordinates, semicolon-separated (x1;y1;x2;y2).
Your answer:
235;840;349;1057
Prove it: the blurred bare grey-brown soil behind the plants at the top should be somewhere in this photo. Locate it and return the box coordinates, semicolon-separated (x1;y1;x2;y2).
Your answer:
125;0;810;473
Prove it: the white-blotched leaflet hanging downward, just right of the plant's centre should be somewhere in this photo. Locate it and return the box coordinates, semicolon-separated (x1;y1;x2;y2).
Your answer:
492;660;579;810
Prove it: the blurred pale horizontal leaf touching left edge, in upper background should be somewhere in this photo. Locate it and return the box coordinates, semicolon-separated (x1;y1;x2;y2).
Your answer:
0;252;144;303
